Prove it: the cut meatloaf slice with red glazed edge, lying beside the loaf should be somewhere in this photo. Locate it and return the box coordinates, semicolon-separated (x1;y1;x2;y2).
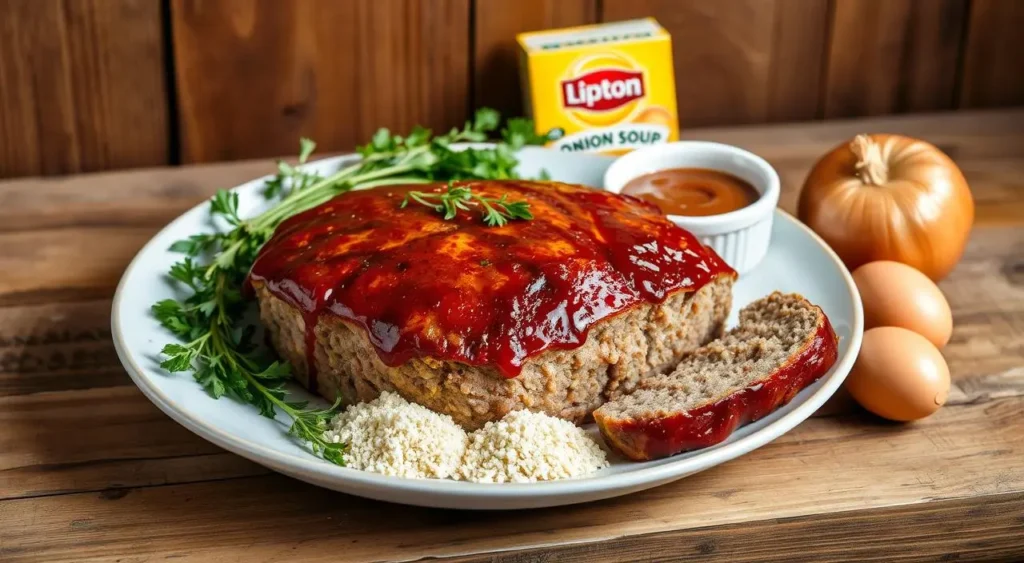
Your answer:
594;293;838;461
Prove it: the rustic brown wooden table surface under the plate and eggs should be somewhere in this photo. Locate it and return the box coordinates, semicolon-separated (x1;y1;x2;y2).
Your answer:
0;111;1024;563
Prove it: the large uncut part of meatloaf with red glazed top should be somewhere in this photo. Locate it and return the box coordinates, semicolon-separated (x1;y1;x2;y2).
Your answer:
249;181;735;429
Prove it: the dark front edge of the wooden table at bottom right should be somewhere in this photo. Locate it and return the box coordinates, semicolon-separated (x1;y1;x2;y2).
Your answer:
442;493;1024;563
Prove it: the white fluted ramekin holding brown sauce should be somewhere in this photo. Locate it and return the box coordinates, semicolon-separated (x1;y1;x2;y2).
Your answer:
604;141;779;274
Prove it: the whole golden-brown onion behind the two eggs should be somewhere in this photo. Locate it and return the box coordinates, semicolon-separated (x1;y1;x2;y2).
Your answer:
797;134;974;282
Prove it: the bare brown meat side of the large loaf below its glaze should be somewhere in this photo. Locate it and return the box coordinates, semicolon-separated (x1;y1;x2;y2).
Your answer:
256;275;734;430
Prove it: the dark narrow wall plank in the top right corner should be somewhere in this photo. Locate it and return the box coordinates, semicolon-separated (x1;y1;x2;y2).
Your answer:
959;0;1024;107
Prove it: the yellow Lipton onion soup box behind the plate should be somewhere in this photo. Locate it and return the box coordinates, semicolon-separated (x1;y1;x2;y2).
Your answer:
516;17;679;155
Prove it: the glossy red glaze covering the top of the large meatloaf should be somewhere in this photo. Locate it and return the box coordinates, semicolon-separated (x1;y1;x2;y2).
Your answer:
249;181;735;385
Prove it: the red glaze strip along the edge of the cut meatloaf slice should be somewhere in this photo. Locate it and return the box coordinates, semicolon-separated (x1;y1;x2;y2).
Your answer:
601;315;839;461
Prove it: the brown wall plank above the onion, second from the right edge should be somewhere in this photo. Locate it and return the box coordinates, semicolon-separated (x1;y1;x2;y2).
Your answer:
823;0;968;118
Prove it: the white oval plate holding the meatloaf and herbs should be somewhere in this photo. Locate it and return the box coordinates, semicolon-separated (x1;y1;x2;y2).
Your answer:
112;148;863;509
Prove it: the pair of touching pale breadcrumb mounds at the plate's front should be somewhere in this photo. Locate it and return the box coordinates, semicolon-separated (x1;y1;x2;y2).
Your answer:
325;392;608;483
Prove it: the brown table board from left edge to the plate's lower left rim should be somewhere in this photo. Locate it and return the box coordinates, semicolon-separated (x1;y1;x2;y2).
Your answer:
0;388;268;503
